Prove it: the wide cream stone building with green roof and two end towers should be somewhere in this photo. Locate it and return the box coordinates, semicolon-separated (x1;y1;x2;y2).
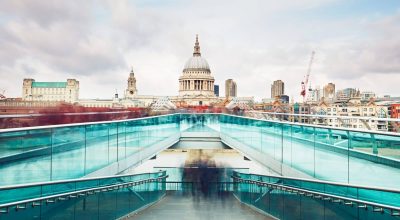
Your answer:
22;79;79;103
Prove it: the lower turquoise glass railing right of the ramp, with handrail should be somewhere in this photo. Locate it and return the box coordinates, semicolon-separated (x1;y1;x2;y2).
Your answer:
233;172;400;219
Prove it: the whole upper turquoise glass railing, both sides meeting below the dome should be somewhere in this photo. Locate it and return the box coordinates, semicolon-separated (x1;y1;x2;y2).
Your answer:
0;113;400;188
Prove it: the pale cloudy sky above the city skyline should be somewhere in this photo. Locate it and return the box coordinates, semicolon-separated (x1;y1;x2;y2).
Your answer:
0;0;400;100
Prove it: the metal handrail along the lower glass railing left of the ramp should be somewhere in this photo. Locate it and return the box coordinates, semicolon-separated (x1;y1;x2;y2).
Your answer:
0;175;168;213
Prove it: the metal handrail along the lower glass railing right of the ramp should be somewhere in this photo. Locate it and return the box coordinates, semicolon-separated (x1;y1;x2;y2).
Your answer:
232;176;400;216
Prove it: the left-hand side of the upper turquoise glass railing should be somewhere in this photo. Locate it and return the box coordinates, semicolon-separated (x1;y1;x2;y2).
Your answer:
0;115;180;185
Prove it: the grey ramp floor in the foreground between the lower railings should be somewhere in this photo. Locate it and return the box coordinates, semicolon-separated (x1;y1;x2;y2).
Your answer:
128;192;275;220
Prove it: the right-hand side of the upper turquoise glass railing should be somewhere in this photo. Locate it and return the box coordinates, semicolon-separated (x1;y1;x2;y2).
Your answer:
220;115;400;188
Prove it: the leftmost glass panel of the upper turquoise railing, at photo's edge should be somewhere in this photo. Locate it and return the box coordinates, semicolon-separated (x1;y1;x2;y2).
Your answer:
0;129;52;185
